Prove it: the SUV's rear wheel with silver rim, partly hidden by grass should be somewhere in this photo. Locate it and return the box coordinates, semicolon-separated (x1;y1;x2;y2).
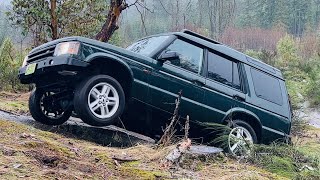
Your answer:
228;120;258;156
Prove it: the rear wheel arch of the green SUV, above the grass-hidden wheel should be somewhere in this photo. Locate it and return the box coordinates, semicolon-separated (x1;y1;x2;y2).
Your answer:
222;108;262;143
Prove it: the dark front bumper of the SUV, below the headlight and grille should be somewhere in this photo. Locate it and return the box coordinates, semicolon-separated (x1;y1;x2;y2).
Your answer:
18;55;89;84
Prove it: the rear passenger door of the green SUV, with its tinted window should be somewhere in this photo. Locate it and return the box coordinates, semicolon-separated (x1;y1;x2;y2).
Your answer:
205;51;246;122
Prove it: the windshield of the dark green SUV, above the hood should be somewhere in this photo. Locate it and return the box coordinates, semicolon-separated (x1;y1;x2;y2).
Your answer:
127;36;169;56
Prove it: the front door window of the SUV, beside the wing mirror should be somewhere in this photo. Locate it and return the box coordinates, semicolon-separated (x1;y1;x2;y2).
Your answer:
161;39;203;74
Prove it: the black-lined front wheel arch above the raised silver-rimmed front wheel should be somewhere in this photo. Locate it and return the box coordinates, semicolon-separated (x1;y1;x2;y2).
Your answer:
85;53;134;100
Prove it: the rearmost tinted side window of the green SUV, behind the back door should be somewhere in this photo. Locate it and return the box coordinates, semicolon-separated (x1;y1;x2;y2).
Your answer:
251;68;283;105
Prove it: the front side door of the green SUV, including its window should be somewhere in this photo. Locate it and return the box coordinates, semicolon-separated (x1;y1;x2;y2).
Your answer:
149;39;205;120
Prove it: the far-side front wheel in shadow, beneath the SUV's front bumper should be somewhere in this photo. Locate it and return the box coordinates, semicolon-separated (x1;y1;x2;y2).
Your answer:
29;89;72;125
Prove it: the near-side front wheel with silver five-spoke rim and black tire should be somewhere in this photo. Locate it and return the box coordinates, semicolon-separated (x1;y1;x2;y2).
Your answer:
73;75;125;126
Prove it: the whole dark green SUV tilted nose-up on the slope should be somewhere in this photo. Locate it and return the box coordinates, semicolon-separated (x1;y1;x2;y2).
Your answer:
19;30;291;149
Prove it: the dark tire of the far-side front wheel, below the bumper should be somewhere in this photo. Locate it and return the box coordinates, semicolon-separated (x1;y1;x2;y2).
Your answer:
29;89;72;125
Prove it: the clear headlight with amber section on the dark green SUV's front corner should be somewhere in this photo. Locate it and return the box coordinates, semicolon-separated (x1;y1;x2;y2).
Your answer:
54;42;80;56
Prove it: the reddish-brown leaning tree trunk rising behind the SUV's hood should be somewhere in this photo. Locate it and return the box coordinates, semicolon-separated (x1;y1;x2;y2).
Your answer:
96;0;128;42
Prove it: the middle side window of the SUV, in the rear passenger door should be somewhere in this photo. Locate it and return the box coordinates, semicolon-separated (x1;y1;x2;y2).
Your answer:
208;52;241;89
